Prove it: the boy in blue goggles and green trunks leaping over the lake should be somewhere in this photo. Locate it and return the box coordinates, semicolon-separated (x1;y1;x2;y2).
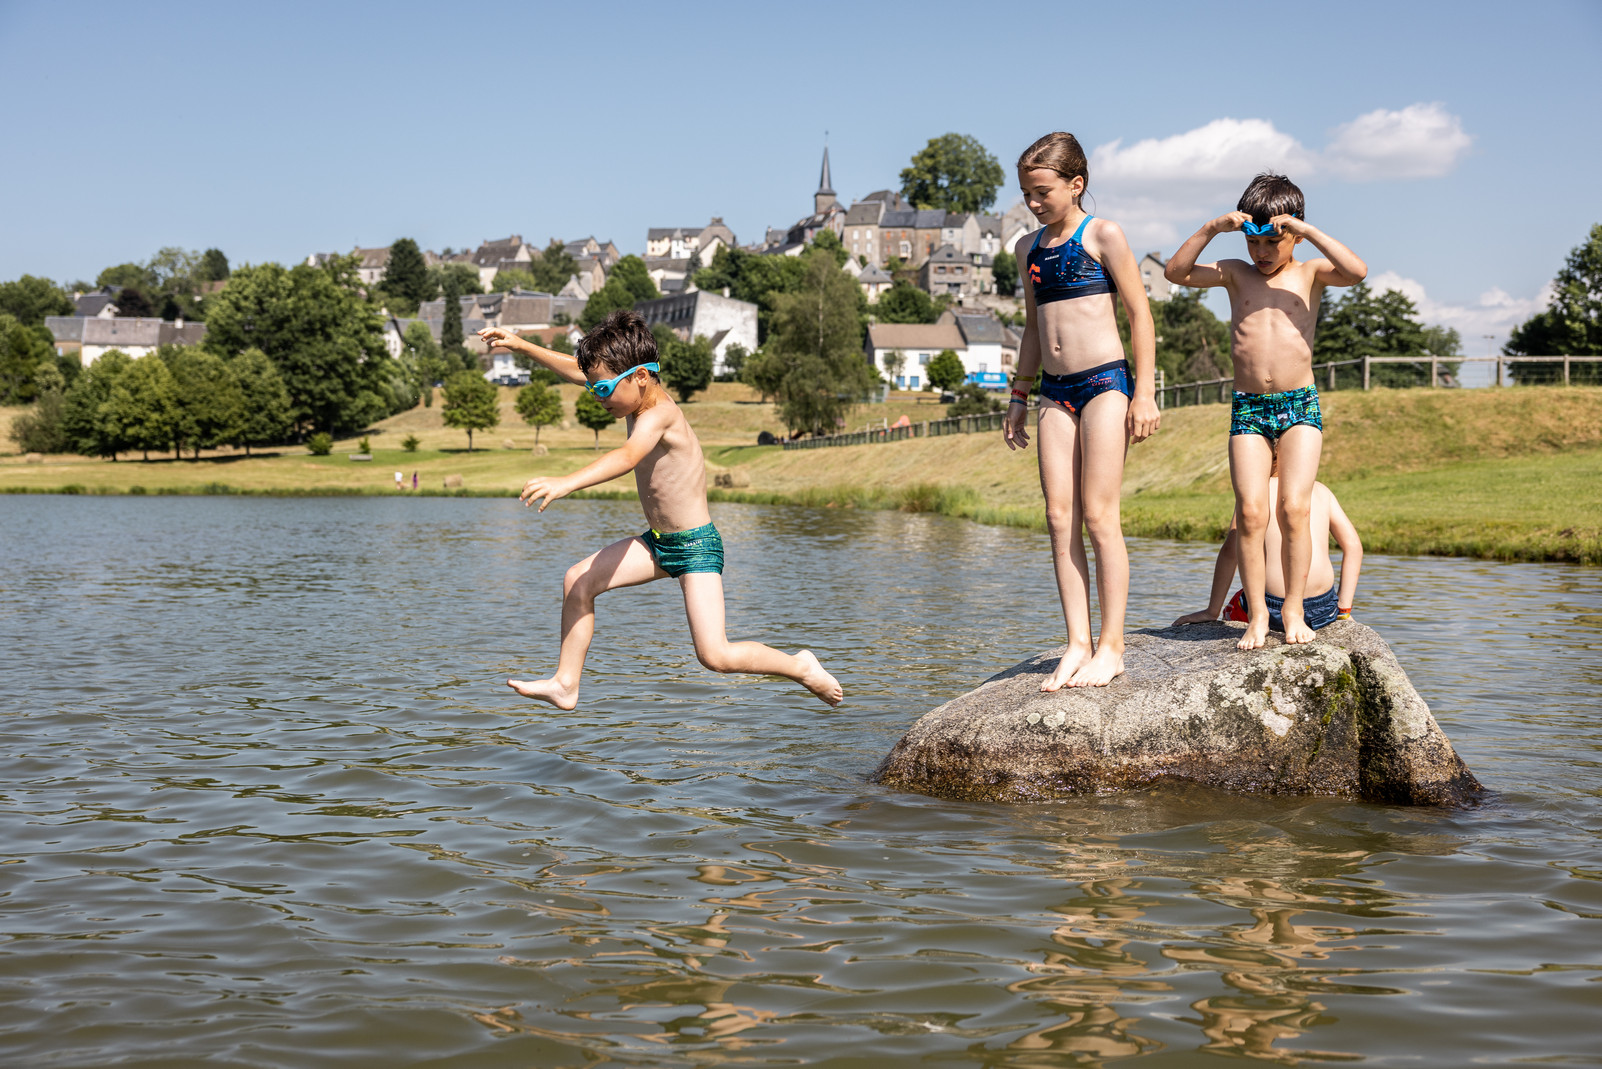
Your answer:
479;311;841;708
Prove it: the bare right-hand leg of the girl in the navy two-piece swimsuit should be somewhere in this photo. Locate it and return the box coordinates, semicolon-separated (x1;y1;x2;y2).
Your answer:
1069;389;1129;686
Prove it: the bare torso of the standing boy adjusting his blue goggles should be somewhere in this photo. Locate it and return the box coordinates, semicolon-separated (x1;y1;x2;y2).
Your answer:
1219;260;1323;393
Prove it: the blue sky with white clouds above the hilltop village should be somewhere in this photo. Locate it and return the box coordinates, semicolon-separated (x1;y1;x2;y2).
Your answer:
0;0;1602;354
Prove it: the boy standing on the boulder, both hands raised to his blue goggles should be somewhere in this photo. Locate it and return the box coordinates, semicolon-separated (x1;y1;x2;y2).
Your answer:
1163;175;1368;649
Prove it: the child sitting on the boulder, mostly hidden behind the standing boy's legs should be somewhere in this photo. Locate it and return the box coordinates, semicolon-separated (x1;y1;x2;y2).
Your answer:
1174;450;1363;631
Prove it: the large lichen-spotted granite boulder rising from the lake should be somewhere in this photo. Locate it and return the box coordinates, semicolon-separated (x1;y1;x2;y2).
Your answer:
873;620;1483;805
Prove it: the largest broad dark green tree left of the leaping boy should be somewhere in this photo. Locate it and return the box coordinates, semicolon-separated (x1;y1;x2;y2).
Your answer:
205;256;397;433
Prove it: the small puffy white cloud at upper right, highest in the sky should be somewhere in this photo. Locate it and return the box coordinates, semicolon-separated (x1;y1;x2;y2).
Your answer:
1323;104;1474;181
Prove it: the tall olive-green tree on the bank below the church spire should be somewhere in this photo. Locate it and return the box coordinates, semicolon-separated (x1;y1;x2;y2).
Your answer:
766;248;878;434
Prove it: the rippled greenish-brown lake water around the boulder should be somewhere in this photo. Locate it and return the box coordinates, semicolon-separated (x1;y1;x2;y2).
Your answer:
0;497;1602;1069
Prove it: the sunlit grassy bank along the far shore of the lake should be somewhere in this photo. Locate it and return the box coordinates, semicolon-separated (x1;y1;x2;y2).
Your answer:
0;385;1602;564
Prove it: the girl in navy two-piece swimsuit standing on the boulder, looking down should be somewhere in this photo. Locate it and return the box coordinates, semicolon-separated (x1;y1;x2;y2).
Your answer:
1003;133;1161;691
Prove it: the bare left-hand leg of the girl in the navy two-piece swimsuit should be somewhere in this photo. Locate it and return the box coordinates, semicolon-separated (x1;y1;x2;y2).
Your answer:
1038;401;1091;691
